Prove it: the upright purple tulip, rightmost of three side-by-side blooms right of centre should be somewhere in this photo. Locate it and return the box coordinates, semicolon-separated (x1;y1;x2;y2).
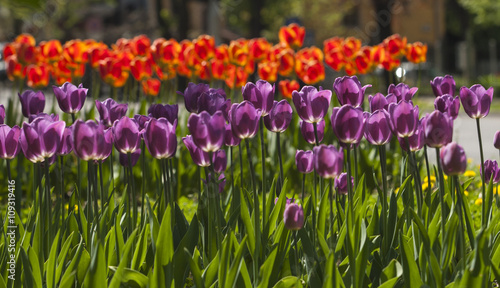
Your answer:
389;100;418;138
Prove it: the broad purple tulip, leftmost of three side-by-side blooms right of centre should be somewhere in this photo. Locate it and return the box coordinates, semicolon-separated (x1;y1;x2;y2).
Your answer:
331;105;365;144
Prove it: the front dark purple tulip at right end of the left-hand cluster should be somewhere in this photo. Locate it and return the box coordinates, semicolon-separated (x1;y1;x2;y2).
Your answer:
143;118;177;159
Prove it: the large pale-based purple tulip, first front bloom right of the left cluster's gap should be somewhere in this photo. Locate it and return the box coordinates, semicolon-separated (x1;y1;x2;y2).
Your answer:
188;111;226;152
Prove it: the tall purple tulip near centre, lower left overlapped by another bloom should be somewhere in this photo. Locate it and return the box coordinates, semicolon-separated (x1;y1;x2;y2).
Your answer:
241;80;274;117
